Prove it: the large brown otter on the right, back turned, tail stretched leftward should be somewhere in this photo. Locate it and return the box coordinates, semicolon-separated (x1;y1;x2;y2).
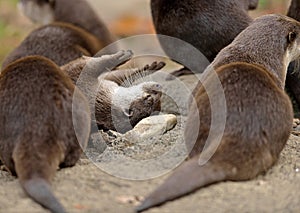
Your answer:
137;15;300;211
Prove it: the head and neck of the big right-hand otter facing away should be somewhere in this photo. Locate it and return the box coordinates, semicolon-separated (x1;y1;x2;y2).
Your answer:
220;14;300;87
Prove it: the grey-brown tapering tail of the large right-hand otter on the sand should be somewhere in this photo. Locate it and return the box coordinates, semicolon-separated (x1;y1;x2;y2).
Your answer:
136;157;226;212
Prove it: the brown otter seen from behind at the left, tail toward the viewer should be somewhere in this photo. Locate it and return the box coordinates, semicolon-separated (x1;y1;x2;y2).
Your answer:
0;56;90;213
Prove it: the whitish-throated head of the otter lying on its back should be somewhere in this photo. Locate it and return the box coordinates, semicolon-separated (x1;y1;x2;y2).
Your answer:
111;82;162;133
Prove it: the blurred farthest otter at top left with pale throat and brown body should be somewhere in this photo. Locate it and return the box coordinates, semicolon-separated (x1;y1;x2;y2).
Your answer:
18;0;115;46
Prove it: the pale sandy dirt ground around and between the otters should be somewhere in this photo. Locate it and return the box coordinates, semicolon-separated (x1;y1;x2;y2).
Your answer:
0;0;300;213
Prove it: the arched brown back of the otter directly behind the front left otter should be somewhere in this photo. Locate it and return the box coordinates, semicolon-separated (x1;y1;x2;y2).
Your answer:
2;22;103;68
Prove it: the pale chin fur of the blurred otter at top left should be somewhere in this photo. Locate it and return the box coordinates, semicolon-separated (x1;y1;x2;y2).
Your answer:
18;2;55;25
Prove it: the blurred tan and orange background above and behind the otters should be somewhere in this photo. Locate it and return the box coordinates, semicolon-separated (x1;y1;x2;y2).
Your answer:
0;0;290;67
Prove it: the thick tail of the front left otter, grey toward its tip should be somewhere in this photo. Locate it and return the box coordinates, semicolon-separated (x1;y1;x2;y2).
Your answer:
13;143;66;213
